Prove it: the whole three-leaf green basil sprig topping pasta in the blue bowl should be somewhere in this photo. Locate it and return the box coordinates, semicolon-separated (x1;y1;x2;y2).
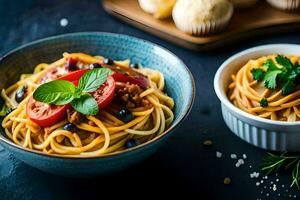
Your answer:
33;68;113;115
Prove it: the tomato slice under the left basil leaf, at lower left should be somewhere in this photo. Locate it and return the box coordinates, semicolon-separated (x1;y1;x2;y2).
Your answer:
26;97;70;127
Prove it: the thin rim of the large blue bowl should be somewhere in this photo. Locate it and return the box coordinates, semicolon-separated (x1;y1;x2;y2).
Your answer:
0;31;196;160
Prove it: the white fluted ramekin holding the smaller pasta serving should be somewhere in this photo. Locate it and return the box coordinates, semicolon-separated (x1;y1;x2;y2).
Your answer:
214;44;300;152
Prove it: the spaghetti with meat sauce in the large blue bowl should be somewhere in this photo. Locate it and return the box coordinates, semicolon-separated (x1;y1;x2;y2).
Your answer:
1;53;174;157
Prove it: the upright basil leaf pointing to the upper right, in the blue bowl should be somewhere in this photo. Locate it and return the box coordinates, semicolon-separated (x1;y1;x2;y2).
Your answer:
78;68;113;92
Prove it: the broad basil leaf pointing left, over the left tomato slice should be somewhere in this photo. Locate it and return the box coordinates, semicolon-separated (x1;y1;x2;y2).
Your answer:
33;80;75;105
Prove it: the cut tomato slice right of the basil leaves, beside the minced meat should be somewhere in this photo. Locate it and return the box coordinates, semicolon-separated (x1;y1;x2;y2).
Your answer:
92;76;116;109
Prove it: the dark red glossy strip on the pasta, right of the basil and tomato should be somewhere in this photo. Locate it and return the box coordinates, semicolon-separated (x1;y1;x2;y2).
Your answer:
112;72;150;88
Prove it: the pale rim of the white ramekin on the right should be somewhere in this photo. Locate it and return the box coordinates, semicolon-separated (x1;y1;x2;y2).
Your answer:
214;43;300;127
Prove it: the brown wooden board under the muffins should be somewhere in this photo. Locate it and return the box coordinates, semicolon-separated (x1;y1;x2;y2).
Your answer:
103;0;300;50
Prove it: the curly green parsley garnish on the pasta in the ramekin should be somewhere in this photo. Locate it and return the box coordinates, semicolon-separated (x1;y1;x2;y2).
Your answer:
251;55;300;96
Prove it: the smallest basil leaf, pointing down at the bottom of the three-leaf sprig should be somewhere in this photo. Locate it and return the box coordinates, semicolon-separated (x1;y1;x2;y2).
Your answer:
71;94;99;115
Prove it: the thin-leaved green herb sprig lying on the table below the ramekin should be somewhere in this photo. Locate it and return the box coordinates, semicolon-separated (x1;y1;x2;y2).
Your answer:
261;153;300;190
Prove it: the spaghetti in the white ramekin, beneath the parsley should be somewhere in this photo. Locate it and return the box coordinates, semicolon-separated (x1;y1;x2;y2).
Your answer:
228;55;300;122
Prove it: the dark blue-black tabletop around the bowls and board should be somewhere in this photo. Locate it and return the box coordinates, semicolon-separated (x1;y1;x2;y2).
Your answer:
0;0;300;200
